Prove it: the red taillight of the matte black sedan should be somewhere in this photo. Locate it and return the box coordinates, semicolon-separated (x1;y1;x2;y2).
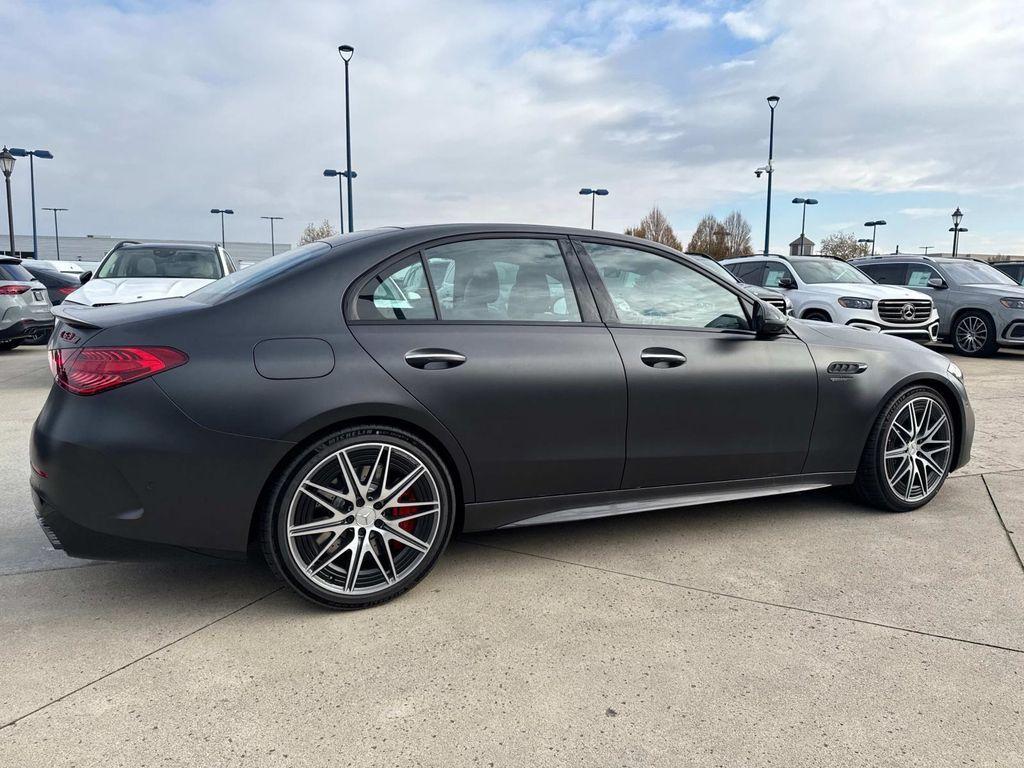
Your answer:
50;347;188;394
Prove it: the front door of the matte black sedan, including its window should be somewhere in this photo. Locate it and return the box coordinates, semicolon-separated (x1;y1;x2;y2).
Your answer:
579;239;817;488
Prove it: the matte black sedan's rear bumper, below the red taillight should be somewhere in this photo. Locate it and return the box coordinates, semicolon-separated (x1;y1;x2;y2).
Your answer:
30;380;291;559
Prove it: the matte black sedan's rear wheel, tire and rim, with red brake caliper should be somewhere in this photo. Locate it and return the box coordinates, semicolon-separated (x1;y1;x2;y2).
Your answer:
264;428;454;608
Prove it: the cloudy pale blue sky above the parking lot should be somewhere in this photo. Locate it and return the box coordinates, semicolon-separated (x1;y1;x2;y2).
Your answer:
0;0;1024;254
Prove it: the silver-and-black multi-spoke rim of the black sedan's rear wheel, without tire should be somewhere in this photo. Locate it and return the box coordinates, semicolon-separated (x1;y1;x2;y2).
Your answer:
285;442;440;595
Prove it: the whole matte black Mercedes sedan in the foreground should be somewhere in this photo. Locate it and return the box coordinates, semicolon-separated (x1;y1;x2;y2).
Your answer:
31;224;974;608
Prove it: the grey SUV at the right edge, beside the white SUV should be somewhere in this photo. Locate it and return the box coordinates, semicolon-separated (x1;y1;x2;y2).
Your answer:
855;256;1024;356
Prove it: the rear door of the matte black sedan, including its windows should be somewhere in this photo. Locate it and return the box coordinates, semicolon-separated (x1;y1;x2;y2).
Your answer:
349;236;626;502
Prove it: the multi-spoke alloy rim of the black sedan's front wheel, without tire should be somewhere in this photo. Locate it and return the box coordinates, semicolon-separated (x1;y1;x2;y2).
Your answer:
885;397;952;502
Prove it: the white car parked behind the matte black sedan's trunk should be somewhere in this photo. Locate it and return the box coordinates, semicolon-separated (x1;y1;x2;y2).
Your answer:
65;243;236;306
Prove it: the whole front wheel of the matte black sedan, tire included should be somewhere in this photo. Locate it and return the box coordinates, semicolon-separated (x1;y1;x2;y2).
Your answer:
855;387;954;512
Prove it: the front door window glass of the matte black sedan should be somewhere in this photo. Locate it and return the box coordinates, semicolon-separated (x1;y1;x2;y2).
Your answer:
587;243;750;329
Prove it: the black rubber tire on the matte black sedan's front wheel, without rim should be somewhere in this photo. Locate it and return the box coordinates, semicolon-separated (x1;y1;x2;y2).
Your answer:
853;386;953;512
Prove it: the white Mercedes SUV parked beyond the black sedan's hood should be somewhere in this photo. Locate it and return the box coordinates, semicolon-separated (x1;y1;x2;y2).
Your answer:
722;255;939;342
